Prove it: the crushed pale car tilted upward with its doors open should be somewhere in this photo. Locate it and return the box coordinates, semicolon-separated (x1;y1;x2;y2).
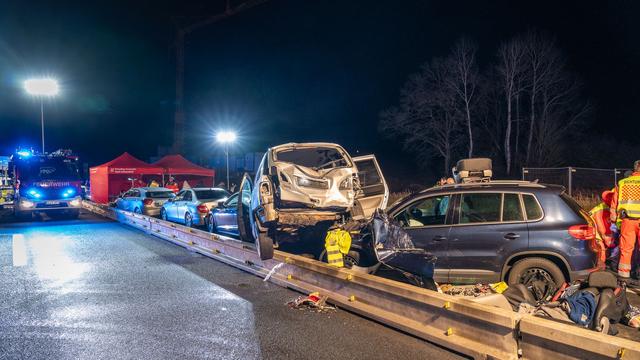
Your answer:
238;143;389;260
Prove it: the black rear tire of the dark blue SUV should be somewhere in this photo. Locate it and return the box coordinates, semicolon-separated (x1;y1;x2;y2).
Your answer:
507;257;565;297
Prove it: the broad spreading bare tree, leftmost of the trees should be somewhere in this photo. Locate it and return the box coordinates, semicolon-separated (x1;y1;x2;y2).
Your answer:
380;59;464;174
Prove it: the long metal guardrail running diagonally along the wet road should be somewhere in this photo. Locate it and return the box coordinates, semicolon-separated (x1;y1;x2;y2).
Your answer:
84;201;640;359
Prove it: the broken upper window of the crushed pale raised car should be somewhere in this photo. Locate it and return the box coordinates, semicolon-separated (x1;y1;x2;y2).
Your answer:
275;147;350;170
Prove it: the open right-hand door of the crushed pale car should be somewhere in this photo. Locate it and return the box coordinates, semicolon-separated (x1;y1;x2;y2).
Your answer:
353;155;389;218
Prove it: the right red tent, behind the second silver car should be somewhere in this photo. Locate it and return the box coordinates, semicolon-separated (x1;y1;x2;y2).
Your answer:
153;155;216;186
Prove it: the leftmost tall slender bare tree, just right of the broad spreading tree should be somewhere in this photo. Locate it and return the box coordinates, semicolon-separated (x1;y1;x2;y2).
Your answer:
447;38;479;157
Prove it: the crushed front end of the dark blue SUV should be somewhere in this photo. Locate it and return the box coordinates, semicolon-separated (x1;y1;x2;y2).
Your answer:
368;209;436;278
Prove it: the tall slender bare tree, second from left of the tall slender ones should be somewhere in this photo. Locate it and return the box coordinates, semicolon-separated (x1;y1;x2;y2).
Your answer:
496;37;524;174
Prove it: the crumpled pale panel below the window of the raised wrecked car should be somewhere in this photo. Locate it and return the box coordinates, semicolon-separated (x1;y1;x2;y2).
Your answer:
276;162;355;209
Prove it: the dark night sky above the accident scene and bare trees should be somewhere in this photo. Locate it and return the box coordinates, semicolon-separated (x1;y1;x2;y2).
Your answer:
0;0;640;180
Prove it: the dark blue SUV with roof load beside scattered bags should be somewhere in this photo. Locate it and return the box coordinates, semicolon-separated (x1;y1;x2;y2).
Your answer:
388;181;598;291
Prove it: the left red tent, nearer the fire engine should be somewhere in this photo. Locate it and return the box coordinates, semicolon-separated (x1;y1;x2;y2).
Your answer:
89;152;163;204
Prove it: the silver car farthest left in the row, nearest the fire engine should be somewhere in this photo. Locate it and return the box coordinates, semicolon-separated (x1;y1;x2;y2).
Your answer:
116;187;175;216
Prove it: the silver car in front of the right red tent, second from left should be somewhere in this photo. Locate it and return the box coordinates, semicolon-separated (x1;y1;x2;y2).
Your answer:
160;188;231;227
